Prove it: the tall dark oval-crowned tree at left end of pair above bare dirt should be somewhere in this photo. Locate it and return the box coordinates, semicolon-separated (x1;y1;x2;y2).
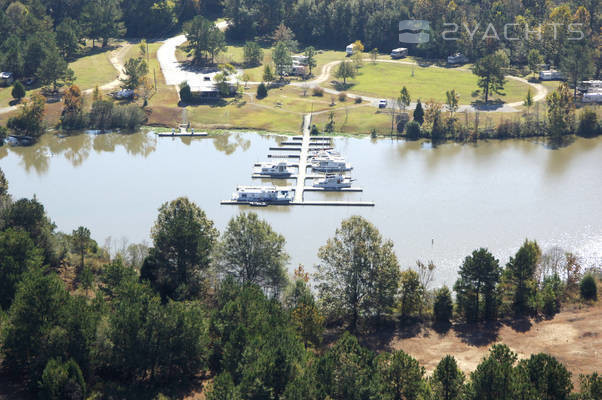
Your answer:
454;248;501;322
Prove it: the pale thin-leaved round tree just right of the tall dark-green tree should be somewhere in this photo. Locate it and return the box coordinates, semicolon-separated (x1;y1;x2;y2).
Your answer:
215;213;289;295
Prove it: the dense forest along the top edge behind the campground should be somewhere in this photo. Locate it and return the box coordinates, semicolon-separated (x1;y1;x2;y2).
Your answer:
0;0;601;79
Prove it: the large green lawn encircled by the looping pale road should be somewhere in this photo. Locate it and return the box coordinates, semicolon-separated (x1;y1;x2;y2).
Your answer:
338;63;528;104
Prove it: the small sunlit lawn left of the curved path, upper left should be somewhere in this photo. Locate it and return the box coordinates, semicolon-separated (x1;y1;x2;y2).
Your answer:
69;49;119;90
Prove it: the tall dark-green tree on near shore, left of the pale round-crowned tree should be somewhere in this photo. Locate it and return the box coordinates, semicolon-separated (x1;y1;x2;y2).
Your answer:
140;197;218;300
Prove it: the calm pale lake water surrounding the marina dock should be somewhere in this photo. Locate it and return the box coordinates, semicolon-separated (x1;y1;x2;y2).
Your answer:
0;133;602;284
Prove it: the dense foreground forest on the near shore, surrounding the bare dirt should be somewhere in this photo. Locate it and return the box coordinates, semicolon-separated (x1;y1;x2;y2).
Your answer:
0;167;602;400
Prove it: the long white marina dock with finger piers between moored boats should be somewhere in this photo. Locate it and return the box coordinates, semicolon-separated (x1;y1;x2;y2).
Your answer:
220;114;374;207
